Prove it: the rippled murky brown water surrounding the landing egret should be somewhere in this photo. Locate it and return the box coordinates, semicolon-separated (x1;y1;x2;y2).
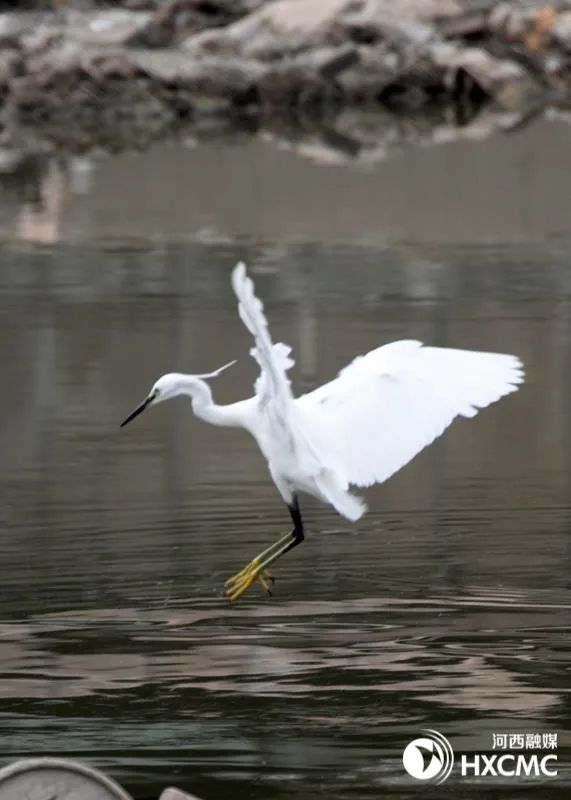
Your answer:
0;119;571;800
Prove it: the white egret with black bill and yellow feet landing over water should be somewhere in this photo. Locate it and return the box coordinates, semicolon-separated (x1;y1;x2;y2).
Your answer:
121;264;523;600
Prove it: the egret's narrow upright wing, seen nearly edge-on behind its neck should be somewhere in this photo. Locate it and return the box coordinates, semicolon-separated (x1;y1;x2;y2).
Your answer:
232;263;294;429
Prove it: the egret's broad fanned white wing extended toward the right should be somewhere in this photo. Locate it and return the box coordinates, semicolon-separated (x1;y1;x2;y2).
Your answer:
295;341;523;486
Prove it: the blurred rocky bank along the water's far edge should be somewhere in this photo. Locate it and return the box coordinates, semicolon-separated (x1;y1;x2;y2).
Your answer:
0;0;571;153
